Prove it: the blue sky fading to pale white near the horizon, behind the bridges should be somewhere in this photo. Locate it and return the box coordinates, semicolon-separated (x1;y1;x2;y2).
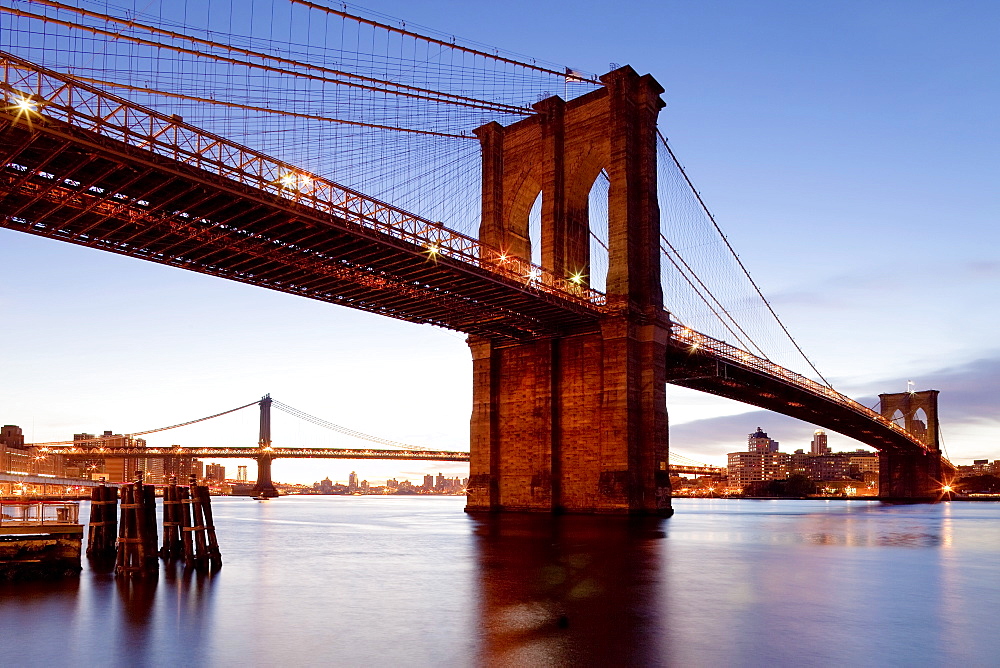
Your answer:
0;0;1000;483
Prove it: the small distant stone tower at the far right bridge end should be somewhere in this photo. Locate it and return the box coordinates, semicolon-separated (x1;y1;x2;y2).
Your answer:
878;390;944;501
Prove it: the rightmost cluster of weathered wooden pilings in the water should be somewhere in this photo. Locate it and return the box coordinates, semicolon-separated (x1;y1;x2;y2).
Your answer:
160;476;222;571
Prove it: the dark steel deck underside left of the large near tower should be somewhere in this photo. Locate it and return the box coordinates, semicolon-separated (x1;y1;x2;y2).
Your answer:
0;114;600;338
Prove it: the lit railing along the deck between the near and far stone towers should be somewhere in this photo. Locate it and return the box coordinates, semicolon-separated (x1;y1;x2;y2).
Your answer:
671;325;927;450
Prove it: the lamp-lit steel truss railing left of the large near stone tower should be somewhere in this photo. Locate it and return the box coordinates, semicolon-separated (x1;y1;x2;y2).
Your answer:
0;51;606;307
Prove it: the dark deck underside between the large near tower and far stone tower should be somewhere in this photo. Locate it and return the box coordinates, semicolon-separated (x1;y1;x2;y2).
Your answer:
667;346;923;453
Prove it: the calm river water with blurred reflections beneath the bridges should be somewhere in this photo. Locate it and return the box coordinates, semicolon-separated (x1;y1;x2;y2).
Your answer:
0;496;1000;668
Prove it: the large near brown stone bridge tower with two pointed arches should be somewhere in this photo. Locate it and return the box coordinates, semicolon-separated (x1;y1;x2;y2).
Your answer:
467;67;672;515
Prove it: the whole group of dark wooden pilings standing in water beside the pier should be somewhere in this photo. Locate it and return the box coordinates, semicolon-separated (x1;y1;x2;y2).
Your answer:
94;471;222;577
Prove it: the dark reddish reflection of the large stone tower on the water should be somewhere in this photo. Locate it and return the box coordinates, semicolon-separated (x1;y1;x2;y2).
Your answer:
474;515;666;666
